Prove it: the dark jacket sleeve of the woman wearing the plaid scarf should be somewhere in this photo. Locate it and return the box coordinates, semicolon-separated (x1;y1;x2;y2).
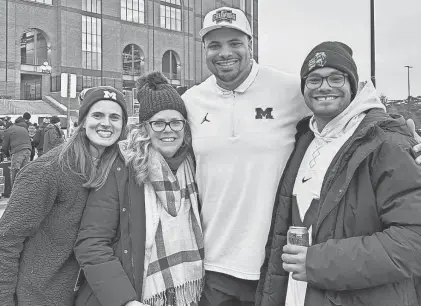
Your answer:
74;167;137;306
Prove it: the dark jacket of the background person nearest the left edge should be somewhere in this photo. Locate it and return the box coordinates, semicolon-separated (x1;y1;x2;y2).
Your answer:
2;121;32;157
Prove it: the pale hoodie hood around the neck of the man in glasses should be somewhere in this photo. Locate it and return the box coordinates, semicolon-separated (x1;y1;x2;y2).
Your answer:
310;81;386;142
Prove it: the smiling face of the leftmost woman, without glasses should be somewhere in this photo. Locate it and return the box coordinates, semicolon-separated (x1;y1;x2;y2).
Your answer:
83;100;123;157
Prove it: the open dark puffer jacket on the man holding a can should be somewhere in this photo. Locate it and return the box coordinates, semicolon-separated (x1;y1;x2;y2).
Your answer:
256;110;421;306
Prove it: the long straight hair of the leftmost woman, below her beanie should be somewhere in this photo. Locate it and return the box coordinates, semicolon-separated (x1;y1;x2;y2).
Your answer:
58;114;127;189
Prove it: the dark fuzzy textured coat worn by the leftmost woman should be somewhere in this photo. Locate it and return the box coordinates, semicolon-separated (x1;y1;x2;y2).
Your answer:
0;146;88;306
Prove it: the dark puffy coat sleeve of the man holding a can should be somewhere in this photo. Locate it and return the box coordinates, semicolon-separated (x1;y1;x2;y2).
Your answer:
306;143;421;291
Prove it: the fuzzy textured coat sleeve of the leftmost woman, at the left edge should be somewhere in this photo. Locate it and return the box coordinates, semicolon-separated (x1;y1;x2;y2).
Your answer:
0;161;59;305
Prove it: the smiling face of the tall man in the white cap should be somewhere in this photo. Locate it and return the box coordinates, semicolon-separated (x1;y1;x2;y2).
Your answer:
203;28;251;90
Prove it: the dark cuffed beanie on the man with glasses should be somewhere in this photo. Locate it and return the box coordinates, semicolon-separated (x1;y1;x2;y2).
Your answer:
300;41;358;100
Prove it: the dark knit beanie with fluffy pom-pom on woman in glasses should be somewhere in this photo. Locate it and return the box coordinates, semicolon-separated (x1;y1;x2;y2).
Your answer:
136;71;187;122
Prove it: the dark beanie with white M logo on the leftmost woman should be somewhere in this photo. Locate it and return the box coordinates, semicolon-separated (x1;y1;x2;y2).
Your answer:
78;86;128;123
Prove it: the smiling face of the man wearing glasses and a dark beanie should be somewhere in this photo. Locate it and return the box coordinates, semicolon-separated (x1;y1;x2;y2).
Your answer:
304;67;351;130
